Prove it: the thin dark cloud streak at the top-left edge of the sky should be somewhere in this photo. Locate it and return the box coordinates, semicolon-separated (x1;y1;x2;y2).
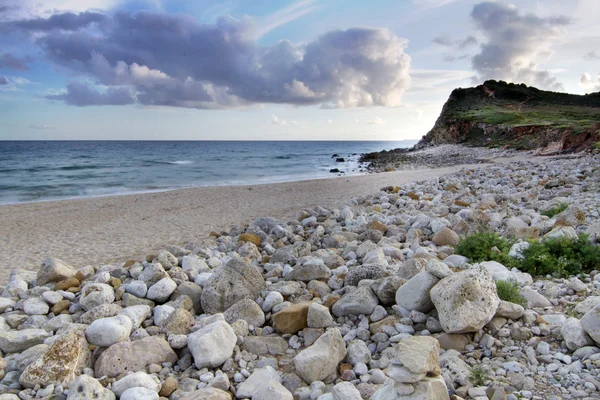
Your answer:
0;11;108;32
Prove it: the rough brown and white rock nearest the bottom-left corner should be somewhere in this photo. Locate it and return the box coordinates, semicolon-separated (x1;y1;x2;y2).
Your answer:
19;331;92;388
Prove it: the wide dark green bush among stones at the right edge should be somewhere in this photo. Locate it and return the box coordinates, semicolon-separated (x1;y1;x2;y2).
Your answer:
517;234;600;276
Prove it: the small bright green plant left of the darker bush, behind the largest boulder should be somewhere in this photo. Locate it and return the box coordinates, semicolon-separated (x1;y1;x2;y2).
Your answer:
454;232;512;265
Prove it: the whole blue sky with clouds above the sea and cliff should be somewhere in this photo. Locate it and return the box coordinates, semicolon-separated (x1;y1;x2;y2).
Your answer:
0;0;600;140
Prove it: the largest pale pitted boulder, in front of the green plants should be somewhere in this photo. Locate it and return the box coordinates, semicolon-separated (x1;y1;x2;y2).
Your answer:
431;267;500;333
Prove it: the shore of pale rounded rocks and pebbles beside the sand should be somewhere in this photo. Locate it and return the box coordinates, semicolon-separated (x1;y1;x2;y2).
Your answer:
0;154;600;400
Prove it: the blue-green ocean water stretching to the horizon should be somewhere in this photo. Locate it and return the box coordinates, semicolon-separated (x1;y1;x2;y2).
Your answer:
0;141;414;204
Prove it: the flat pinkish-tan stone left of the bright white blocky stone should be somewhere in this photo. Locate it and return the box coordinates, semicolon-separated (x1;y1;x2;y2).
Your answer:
94;336;177;377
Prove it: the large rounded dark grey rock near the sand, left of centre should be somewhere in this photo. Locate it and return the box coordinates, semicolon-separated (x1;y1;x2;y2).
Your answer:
201;258;266;314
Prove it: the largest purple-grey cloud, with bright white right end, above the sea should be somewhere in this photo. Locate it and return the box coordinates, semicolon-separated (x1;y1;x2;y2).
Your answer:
11;10;411;109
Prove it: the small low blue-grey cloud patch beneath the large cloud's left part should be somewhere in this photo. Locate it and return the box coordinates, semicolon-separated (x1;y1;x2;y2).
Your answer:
46;83;135;107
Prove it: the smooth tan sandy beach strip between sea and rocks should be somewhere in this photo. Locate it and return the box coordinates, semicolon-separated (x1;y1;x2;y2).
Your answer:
0;158;524;282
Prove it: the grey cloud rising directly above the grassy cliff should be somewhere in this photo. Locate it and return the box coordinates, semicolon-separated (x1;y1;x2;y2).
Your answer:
471;1;571;90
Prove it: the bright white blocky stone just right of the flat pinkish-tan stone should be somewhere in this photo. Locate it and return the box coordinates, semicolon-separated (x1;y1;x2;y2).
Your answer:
188;321;237;369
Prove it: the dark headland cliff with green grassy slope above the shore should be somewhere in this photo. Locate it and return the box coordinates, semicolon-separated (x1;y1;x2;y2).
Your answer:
415;81;600;154
